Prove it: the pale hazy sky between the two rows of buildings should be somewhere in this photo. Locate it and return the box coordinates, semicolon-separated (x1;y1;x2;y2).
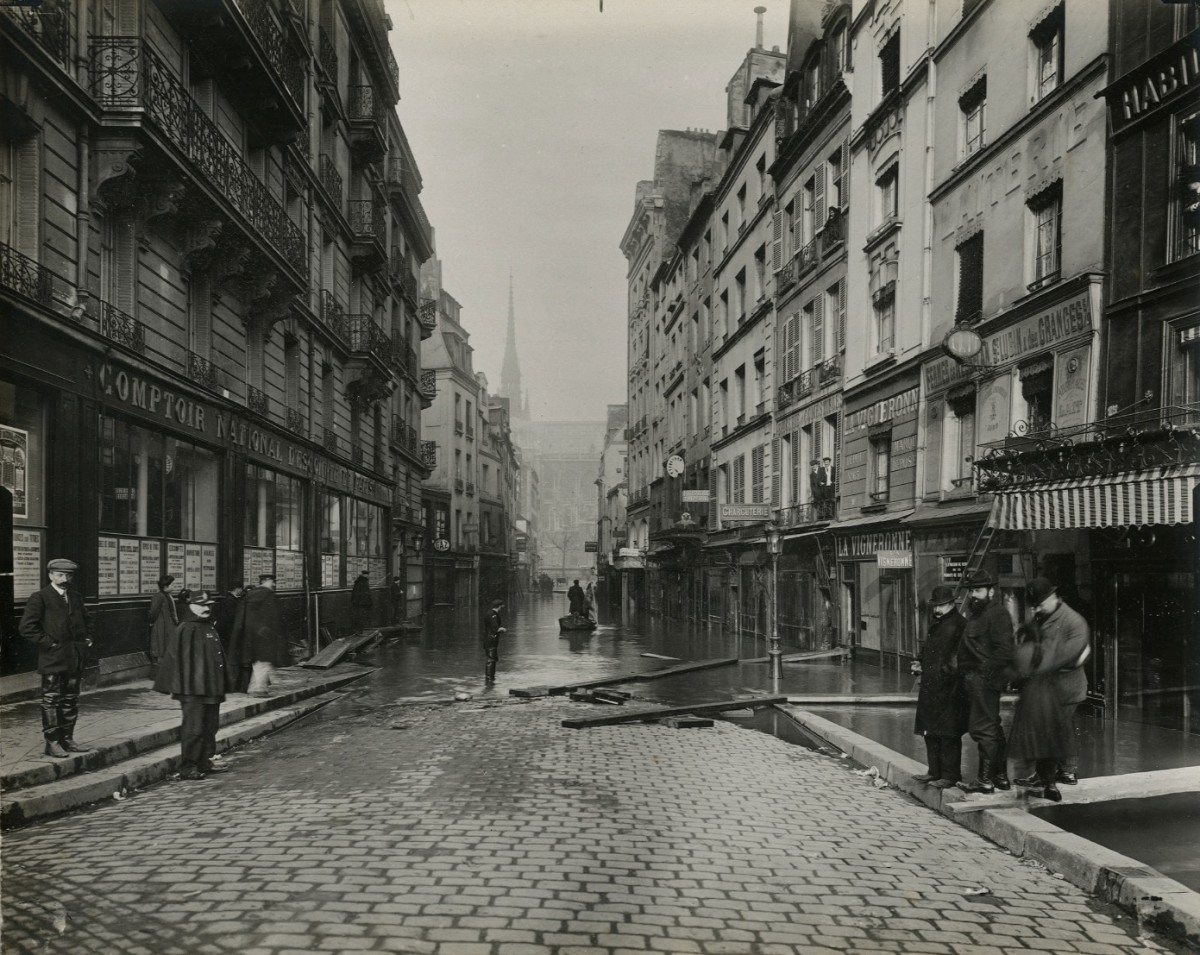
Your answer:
385;0;787;420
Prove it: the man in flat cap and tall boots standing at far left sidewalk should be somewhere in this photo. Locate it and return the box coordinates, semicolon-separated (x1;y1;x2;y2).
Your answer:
19;557;94;759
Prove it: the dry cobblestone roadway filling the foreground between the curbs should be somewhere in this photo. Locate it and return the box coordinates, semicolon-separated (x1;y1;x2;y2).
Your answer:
4;699;1170;955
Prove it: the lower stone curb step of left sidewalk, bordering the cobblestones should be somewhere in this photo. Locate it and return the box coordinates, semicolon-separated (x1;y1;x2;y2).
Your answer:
0;687;336;829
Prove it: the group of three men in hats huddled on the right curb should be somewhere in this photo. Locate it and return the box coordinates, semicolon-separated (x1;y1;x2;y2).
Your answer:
913;576;1090;801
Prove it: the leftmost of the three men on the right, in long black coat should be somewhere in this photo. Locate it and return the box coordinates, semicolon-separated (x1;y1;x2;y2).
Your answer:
913;584;967;789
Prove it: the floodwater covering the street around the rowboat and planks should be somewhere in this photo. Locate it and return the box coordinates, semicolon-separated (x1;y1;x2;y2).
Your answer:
336;594;913;705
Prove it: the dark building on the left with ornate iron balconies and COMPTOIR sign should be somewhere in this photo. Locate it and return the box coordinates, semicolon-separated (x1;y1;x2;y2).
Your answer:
0;0;432;666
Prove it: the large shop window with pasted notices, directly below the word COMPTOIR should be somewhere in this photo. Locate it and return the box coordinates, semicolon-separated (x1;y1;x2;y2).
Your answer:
97;415;220;596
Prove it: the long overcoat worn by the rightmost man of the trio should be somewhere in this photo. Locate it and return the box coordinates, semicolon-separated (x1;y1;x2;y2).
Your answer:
1008;631;1078;759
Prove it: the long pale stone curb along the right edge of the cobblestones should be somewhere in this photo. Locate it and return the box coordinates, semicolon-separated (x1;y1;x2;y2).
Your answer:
780;707;1200;949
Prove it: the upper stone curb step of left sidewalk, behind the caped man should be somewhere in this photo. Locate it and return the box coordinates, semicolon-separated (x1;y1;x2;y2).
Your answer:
0;669;370;801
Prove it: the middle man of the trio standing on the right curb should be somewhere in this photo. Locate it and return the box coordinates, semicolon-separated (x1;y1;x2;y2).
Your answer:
958;573;1016;793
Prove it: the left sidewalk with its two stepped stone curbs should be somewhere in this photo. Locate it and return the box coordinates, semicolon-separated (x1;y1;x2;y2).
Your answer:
0;663;374;829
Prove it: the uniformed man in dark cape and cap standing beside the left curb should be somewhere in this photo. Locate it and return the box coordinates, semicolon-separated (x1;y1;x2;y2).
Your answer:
154;590;228;780
